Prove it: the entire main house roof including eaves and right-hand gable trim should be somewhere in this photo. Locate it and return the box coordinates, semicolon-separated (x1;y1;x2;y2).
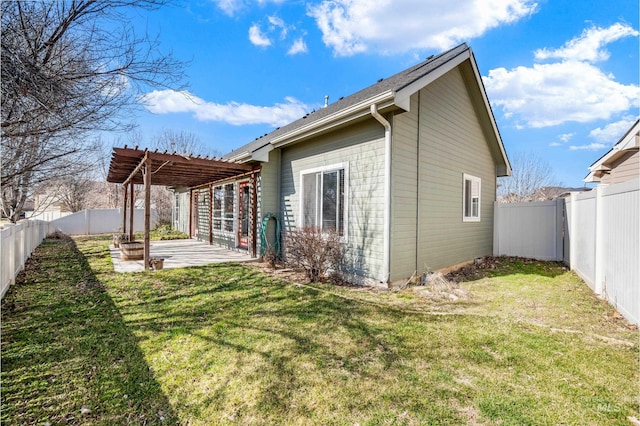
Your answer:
223;43;511;175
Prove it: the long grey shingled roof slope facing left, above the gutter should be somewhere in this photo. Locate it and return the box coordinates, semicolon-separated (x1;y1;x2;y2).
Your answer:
223;43;469;159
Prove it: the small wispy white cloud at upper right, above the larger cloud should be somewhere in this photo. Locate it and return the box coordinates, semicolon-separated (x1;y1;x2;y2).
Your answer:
534;23;640;63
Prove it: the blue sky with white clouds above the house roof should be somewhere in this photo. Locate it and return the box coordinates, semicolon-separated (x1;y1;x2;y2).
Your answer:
113;0;640;186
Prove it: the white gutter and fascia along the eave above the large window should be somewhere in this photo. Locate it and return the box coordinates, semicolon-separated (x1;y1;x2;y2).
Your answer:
270;91;393;148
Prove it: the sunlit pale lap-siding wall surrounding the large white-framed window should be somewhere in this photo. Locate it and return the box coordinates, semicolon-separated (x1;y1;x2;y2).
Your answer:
281;119;384;280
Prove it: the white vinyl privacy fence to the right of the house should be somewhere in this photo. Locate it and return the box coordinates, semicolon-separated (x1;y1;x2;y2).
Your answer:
493;180;640;324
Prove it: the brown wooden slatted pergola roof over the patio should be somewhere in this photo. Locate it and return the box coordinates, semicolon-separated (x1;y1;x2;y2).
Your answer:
107;145;253;187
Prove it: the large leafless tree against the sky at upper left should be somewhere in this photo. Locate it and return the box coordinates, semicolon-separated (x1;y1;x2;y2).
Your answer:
0;0;182;221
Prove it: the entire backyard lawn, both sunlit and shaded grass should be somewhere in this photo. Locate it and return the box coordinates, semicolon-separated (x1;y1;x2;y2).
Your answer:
1;238;640;425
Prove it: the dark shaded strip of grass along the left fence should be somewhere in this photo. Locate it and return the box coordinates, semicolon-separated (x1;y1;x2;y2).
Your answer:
1;238;177;424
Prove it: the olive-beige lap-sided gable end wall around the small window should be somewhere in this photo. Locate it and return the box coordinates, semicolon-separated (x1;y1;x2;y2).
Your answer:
391;69;496;280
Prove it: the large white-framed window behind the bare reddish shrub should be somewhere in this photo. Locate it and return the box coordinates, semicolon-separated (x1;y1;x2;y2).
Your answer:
300;164;347;236
